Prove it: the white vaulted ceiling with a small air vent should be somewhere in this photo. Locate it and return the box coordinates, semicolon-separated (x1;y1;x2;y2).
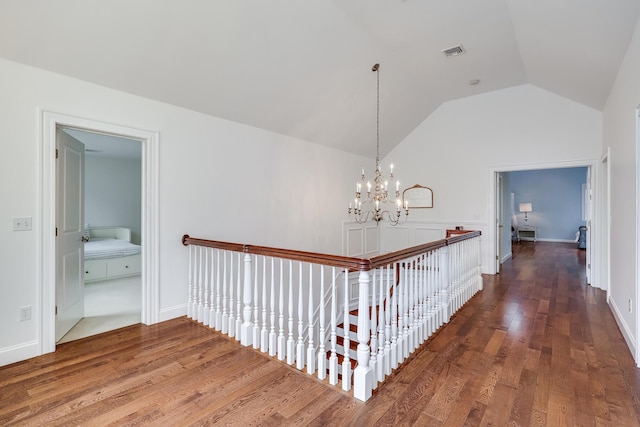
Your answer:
0;0;640;156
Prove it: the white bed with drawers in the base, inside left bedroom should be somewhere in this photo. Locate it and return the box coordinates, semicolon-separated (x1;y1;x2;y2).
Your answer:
84;227;142;282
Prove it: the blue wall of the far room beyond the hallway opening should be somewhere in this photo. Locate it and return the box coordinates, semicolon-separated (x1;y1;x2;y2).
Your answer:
506;167;587;241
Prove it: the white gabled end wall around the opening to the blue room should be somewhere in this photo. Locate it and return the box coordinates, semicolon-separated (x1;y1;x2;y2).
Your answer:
384;84;602;273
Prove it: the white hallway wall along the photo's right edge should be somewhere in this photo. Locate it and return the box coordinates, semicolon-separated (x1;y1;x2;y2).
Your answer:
604;23;640;363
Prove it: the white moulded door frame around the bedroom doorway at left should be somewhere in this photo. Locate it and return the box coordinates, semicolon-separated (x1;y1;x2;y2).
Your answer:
39;111;159;354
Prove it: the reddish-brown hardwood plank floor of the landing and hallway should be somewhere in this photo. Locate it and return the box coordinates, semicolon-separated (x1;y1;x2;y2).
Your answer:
0;242;640;426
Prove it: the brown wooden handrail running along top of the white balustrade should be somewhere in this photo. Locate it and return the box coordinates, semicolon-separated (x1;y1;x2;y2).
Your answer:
182;231;482;271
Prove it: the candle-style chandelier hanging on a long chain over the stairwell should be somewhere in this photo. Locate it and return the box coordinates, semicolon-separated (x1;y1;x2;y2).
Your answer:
349;64;409;225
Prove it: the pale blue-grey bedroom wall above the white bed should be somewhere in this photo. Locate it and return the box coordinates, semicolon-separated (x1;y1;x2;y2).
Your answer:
84;156;142;244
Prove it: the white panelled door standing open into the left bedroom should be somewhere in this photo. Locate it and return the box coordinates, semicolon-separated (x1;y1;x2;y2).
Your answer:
56;129;84;342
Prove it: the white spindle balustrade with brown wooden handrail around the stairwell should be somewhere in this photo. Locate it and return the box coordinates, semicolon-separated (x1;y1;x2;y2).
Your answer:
185;233;482;401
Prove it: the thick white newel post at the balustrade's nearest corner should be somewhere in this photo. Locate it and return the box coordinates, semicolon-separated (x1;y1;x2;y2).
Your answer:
353;271;373;402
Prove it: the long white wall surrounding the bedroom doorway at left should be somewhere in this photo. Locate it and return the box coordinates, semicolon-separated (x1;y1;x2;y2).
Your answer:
0;60;371;365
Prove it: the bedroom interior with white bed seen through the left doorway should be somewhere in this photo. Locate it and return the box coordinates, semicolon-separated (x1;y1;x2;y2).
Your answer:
58;128;143;343
